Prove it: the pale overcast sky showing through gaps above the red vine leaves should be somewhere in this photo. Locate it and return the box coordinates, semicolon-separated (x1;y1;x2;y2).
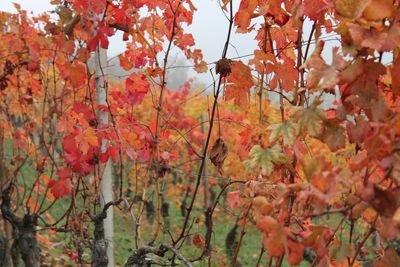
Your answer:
0;0;346;91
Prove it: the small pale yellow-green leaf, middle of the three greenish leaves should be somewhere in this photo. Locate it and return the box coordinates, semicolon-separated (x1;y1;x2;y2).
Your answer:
267;120;299;146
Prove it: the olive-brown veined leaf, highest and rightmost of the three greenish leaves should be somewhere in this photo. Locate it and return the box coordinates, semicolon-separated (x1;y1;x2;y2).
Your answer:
293;102;325;137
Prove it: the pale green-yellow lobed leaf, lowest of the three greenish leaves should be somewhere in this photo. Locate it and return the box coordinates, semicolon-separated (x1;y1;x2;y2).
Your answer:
245;145;287;175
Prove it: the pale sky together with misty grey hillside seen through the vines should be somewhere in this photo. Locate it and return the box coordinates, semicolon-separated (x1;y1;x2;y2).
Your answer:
0;0;346;103
